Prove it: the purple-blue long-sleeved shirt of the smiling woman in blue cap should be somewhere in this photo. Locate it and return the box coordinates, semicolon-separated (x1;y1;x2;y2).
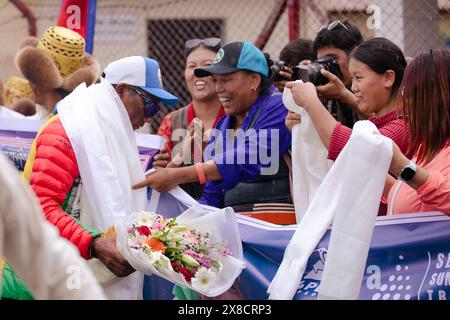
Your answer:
199;86;291;208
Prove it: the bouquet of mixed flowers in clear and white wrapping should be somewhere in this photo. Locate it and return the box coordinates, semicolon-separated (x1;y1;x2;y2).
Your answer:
118;206;244;296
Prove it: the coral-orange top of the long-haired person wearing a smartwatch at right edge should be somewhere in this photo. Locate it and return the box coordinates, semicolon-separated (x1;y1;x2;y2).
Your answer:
388;145;450;215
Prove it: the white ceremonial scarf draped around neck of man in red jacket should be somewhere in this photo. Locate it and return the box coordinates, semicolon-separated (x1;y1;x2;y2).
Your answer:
58;79;146;299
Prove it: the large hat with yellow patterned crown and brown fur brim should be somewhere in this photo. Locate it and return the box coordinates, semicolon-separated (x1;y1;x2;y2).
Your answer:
15;27;101;92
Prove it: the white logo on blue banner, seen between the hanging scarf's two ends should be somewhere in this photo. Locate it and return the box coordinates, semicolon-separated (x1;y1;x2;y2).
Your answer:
296;248;327;299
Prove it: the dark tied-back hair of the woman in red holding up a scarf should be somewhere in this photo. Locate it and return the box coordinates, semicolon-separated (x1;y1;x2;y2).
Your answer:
350;38;407;95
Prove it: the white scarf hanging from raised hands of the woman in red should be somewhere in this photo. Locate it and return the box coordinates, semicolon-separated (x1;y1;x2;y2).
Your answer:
283;88;333;224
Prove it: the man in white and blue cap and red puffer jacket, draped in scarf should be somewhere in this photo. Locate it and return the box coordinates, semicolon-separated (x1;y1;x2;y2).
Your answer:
21;56;178;299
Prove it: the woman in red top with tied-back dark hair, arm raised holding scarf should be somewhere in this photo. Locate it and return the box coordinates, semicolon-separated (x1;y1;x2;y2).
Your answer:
286;38;408;214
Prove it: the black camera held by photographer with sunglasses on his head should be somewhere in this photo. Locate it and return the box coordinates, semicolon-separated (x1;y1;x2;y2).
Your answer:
298;56;343;86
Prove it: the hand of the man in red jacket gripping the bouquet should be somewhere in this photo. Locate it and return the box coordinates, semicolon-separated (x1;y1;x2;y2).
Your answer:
94;237;135;277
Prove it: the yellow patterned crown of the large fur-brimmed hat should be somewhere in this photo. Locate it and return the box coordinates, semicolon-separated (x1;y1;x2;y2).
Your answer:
37;26;84;77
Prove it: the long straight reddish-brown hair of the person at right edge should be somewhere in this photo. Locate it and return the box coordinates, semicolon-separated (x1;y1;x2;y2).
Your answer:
402;49;450;164
